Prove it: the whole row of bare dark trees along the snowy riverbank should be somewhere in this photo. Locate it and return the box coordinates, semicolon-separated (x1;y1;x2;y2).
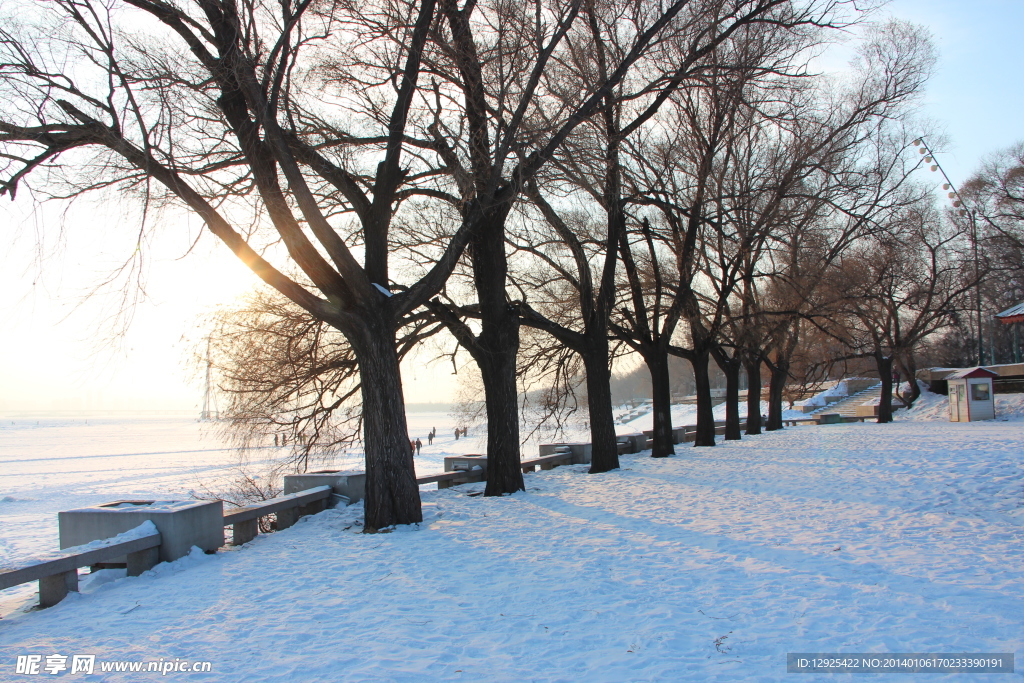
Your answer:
0;0;983;530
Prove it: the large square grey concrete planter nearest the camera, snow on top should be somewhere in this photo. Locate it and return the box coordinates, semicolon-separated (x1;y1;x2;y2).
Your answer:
57;501;224;564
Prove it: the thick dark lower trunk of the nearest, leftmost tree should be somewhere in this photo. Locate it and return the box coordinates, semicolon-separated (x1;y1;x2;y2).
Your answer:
349;321;423;532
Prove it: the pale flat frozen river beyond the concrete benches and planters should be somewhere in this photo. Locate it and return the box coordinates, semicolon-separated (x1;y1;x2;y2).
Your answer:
0;412;484;615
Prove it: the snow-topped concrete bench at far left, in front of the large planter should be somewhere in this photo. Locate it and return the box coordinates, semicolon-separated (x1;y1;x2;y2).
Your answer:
0;522;161;607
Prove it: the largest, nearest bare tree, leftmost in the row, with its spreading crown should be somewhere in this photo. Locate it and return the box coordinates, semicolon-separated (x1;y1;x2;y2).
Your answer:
0;0;470;530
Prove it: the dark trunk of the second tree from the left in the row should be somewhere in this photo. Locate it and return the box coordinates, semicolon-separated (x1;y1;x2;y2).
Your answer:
469;207;524;496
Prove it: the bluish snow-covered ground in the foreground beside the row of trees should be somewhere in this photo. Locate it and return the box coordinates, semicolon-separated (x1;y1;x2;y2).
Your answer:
0;394;1024;681
